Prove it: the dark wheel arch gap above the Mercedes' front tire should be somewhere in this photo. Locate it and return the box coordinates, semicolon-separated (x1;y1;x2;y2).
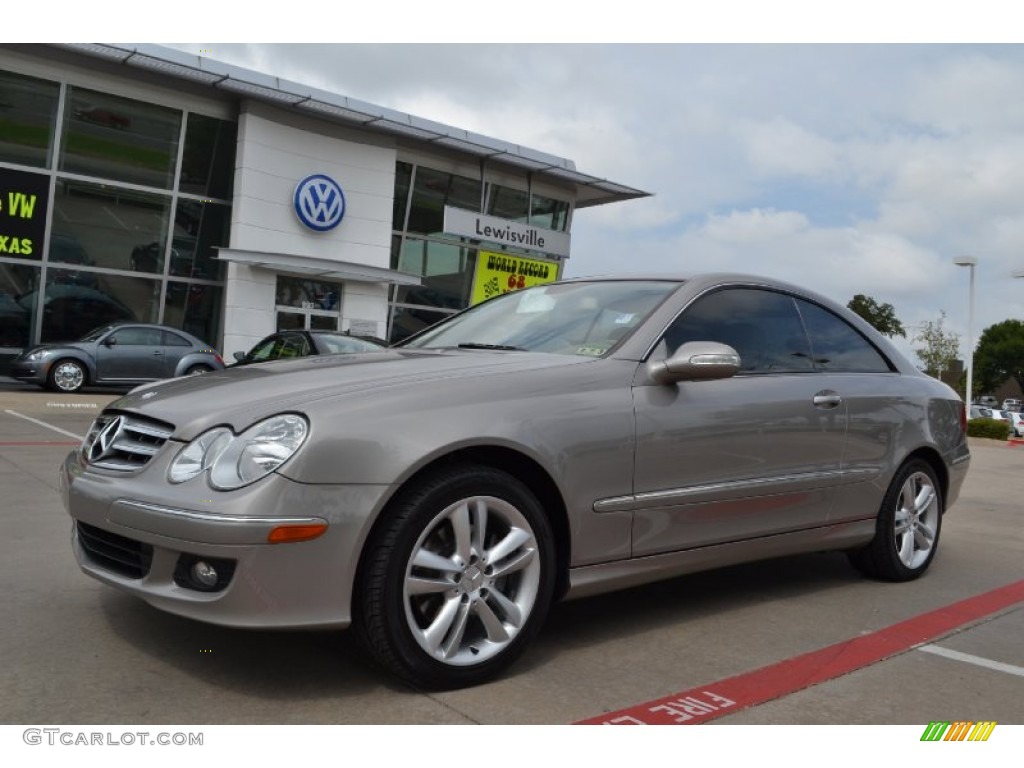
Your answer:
352;445;571;600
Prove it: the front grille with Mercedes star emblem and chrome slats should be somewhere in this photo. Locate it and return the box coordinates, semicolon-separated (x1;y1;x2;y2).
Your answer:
82;412;174;472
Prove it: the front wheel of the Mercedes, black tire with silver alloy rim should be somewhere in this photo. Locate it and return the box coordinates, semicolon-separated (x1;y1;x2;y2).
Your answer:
354;466;555;689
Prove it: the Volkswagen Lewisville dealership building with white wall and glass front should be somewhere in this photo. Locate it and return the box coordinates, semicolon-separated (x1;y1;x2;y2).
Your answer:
0;44;646;358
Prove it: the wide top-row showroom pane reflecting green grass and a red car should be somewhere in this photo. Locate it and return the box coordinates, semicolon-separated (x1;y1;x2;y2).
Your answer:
59;88;181;189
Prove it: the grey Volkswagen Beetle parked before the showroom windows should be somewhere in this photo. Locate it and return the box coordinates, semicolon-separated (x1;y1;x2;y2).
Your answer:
8;323;224;392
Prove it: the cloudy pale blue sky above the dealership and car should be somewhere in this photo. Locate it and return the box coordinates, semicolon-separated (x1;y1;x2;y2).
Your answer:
157;30;1024;364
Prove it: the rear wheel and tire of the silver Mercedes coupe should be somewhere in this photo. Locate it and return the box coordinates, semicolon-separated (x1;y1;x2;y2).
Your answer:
850;459;944;582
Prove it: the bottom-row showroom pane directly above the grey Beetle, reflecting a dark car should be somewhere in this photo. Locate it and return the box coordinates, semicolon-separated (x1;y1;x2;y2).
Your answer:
39;269;160;342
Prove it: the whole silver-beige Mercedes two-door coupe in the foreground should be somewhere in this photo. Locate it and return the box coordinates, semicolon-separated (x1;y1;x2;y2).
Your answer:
60;274;971;689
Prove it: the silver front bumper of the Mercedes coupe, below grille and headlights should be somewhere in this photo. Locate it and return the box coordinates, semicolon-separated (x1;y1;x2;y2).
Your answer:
60;446;388;628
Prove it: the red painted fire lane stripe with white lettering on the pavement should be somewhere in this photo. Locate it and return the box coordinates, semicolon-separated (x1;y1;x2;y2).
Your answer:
575;581;1024;725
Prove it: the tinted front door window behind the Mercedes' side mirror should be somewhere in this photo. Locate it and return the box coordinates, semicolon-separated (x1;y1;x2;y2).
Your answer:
665;289;812;373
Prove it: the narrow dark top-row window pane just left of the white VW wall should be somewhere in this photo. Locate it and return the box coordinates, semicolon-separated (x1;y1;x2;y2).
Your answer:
178;113;239;200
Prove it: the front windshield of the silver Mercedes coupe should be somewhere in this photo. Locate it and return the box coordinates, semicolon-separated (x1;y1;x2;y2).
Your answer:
401;281;679;357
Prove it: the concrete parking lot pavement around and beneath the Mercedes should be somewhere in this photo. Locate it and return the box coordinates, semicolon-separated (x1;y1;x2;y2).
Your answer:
0;381;1024;728
